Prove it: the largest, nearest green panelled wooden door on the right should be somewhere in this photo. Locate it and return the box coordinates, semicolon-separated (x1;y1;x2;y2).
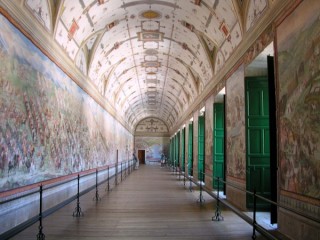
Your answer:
246;77;270;209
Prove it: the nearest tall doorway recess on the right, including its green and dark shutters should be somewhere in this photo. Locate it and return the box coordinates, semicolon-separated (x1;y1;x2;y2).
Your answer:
245;42;277;224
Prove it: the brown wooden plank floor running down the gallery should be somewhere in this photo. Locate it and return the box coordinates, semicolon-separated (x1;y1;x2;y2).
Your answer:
14;165;264;240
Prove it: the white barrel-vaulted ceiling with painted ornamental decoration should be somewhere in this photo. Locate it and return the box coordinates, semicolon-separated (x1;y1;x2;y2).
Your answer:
19;0;270;128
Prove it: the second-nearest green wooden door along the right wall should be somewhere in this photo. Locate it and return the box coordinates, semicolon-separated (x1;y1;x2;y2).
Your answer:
212;103;224;190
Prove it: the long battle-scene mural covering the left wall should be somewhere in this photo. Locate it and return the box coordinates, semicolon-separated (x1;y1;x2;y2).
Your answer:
0;15;133;192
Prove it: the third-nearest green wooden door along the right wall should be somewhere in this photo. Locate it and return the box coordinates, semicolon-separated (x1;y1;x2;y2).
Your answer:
198;116;205;182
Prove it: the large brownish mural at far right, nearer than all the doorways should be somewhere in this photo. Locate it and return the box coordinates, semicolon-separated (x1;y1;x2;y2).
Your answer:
277;0;320;199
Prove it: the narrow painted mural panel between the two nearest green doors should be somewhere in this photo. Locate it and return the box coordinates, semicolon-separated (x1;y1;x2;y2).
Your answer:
226;65;246;180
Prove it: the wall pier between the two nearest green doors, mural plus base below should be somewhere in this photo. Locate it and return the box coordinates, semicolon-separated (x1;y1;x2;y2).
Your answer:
225;65;246;209
